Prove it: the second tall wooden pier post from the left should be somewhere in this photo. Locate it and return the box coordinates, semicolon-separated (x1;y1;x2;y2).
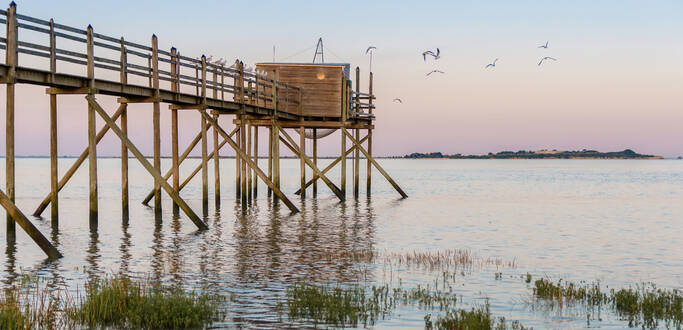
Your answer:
50;19;59;224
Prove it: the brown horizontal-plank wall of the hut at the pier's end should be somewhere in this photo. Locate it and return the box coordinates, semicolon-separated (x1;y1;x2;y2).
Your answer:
256;64;344;118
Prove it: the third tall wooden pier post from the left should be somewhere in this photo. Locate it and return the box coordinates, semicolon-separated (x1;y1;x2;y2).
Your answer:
87;25;98;224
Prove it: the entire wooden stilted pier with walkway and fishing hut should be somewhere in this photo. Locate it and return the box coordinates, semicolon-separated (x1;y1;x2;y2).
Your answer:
0;2;407;258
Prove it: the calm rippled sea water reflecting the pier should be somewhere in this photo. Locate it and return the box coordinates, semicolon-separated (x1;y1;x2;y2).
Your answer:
0;159;683;328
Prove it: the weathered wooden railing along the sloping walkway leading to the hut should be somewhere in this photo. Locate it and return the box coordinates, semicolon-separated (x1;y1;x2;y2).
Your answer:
0;4;301;115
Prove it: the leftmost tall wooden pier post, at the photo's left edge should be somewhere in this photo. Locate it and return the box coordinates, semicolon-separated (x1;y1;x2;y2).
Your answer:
5;2;19;243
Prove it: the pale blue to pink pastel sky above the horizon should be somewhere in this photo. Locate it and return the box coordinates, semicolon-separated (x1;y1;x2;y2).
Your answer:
0;0;683;157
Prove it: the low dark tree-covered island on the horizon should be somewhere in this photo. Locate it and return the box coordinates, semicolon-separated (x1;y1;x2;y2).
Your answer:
403;149;662;159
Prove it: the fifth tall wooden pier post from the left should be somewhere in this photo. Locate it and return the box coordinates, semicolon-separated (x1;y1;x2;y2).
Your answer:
152;35;161;213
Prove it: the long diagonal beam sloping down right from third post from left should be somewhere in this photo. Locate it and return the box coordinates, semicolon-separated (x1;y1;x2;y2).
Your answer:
85;95;209;230
